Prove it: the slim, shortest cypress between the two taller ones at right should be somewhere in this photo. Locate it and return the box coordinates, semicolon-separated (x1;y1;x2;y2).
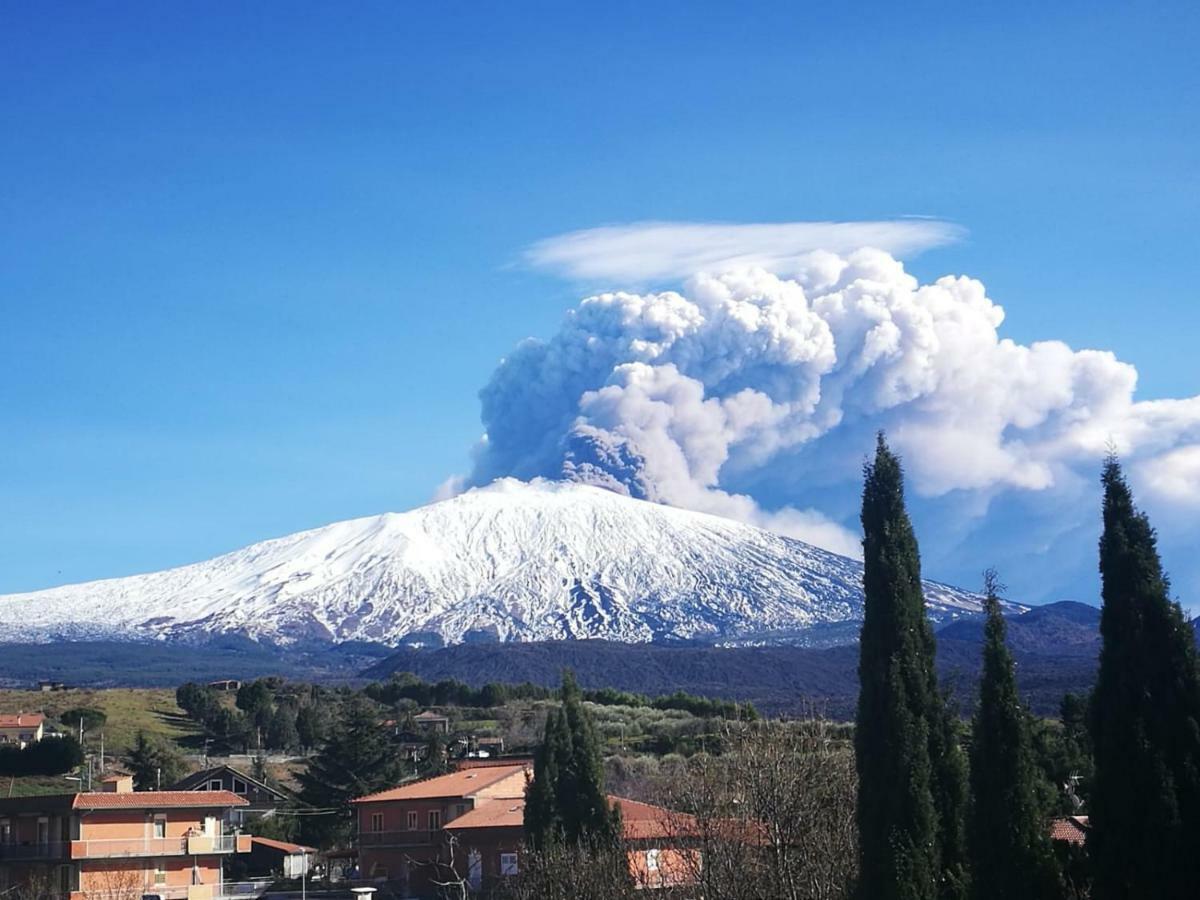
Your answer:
968;571;1057;900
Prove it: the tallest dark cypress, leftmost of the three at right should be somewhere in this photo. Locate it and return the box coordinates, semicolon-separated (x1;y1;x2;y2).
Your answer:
854;433;966;900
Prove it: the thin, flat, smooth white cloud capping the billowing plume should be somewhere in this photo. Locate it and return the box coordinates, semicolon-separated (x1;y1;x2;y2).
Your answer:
524;218;962;283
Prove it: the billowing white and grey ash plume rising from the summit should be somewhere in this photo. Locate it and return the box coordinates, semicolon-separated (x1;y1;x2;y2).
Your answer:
468;250;1200;607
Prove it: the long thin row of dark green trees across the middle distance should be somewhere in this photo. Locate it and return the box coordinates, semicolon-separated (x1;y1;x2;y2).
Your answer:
362;672;758;721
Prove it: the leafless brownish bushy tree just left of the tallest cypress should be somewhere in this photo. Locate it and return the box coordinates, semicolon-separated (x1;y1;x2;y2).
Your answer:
664;720;857;900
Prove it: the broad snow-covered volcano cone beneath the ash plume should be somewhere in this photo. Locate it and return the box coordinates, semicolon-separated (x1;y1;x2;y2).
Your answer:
0;480;980;644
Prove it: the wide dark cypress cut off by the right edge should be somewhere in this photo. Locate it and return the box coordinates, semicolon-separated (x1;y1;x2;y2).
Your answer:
1087;456;1200;900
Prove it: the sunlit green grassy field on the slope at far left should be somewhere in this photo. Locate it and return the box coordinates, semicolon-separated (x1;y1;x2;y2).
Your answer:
0;688;199;756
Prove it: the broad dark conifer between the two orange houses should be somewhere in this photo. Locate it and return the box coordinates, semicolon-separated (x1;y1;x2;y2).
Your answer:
300;697;404;846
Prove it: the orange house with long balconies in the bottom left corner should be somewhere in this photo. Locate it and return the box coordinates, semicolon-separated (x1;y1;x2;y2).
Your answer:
0;778;250;900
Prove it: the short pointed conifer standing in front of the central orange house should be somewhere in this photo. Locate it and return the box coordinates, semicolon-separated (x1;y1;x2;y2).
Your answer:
524;672;620;850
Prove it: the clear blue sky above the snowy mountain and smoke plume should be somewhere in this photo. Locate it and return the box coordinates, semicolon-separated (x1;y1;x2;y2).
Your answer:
0;2;1200;593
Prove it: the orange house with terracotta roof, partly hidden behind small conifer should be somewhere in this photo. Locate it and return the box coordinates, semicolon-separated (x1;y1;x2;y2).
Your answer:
354;762;700;898
